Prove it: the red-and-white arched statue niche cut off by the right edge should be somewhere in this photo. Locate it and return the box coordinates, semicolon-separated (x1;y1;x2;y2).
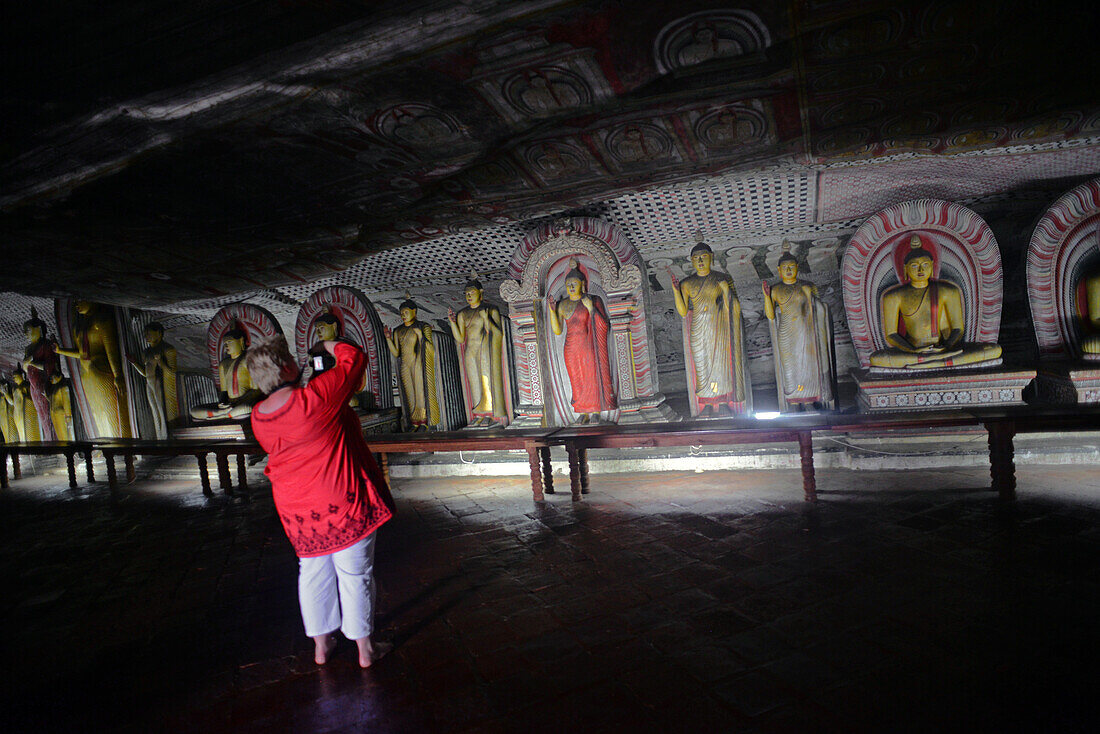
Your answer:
1027;178;1100;403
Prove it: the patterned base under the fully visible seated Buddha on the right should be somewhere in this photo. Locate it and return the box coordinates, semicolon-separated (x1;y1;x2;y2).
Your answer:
853;370;1035;413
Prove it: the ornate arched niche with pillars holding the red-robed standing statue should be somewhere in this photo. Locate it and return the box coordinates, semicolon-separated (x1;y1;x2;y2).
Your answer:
501;218;677;427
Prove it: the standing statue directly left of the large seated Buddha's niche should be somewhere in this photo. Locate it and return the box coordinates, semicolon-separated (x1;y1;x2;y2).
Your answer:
762;242;836;410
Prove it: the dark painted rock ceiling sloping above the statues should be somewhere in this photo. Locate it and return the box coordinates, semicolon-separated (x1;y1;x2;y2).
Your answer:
0;0;1100;312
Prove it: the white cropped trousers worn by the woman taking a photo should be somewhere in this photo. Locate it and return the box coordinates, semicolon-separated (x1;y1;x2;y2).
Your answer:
298;533;376;639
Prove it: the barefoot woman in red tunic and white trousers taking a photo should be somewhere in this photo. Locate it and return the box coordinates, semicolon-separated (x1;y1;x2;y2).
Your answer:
245;336;394;668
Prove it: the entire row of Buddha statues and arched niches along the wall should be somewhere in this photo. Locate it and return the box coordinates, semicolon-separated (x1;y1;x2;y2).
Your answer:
0;179;1100;440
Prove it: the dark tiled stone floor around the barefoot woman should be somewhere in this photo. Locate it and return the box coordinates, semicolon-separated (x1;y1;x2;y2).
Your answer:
0;467;1100;734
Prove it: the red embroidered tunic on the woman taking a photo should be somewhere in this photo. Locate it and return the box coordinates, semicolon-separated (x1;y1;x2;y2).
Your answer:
252;343;393;558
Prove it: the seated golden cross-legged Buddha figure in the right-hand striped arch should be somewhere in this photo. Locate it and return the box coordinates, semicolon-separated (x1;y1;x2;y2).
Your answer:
870;234;1001;370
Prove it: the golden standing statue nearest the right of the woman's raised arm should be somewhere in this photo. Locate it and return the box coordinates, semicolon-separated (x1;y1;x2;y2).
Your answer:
385;293;440;430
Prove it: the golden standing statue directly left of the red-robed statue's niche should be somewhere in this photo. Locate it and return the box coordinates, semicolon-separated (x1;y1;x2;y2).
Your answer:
447;274;507;427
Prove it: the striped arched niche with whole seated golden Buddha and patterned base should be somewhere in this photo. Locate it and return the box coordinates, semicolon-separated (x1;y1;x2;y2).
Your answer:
844;199;1035;412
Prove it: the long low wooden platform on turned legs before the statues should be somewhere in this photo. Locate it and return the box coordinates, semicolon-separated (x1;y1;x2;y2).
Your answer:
0;406;1100;502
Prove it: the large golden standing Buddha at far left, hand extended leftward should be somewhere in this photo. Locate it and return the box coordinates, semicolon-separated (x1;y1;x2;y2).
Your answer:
54;300;132;438
